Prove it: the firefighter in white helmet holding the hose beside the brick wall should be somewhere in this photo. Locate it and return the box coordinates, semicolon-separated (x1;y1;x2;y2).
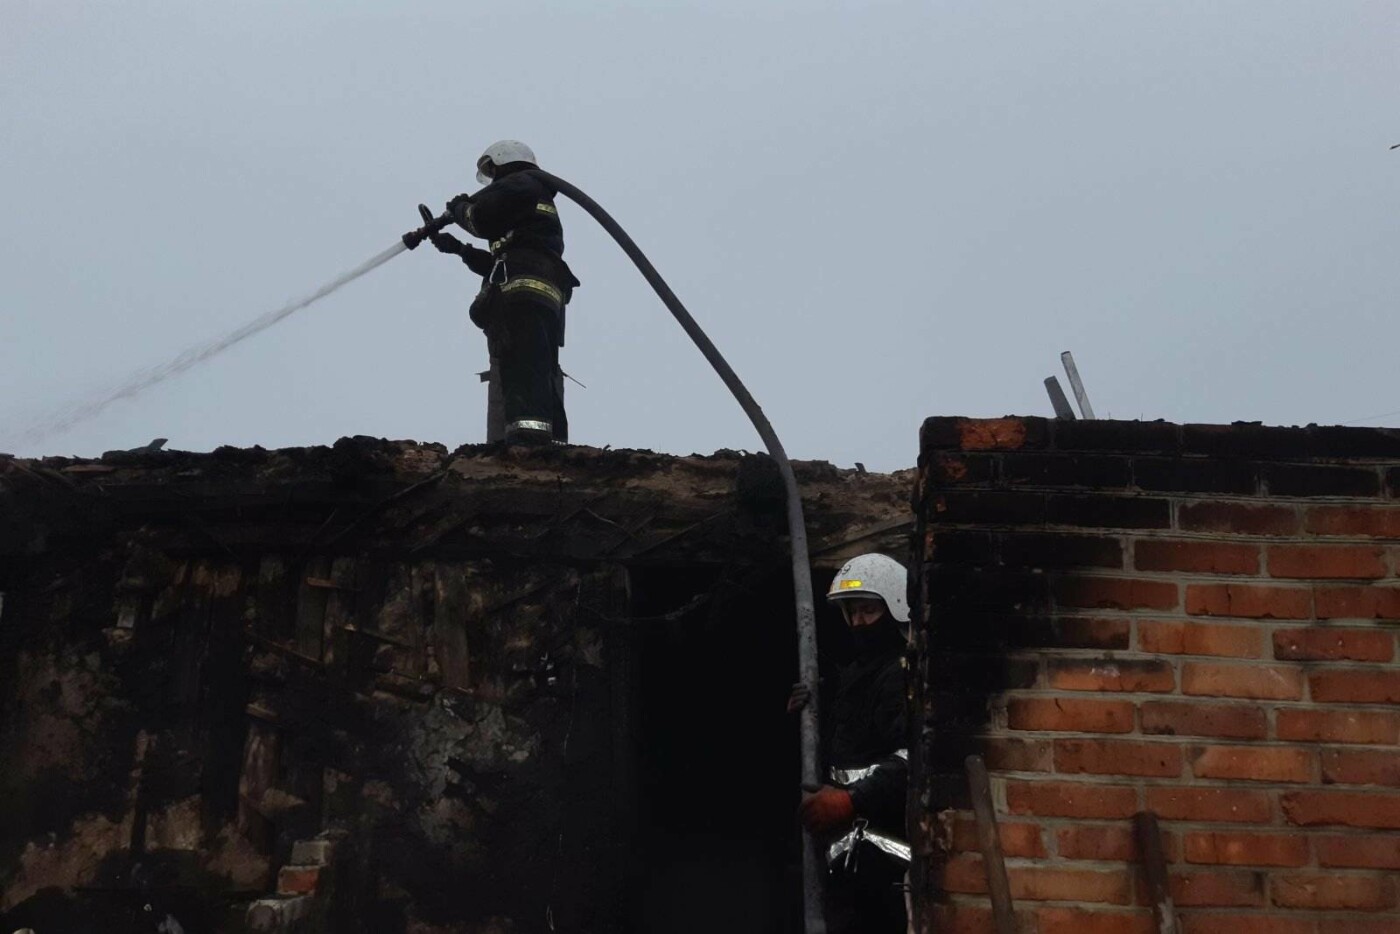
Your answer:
788;555;910;934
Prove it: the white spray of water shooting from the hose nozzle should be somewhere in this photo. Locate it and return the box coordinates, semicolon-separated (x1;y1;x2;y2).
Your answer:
14;241;407;444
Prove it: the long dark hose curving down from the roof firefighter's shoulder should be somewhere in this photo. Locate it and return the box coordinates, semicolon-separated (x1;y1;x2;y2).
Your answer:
528;169;826;934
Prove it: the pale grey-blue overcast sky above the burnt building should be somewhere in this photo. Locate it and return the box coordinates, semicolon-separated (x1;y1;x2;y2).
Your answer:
0;0;1400;471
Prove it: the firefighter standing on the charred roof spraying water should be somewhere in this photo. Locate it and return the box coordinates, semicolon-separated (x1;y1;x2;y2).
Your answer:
431;140;578;442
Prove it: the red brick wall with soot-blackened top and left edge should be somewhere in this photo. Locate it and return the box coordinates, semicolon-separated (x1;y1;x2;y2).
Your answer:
911;419;1400;934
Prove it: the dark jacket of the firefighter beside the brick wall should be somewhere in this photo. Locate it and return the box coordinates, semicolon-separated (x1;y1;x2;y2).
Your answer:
827;619;909;839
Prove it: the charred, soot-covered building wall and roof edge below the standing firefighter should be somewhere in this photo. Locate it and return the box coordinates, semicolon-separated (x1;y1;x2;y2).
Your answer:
0;438;909;934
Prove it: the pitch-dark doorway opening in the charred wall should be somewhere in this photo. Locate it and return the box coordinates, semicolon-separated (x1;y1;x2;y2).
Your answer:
629;567;801;934
